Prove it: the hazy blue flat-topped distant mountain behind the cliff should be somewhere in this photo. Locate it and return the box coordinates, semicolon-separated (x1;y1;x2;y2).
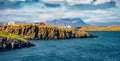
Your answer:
46;18;88;27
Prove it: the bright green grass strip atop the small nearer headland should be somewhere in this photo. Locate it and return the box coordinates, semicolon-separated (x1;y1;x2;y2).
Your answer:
0;31;25;41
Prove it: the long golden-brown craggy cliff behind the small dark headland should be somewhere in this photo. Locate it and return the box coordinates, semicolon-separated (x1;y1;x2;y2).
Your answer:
0;24;94;39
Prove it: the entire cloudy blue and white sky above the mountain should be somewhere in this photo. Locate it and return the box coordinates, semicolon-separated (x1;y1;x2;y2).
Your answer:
0;0;120;25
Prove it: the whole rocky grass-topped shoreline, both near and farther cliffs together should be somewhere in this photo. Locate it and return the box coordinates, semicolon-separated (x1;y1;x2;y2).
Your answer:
0;23;96;50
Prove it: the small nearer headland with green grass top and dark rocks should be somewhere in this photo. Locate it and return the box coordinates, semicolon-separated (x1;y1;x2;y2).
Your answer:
0;31;34;51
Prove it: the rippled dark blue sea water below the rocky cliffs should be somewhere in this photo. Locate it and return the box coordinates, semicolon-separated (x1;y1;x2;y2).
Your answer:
0;32;120;61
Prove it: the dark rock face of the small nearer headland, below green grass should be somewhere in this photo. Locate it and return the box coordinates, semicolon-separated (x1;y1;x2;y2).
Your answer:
0;36;34;51
